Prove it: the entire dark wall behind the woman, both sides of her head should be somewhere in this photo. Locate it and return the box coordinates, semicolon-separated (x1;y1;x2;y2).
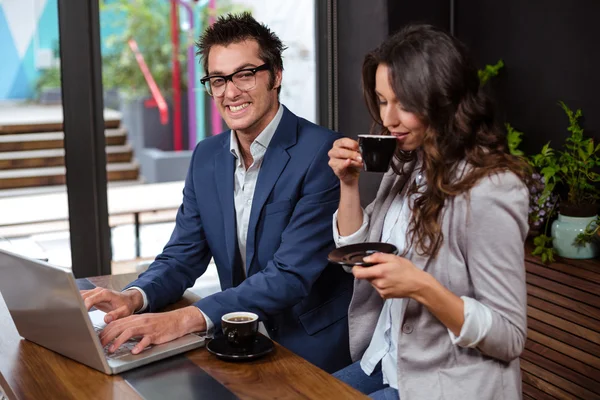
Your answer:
330;0;600;202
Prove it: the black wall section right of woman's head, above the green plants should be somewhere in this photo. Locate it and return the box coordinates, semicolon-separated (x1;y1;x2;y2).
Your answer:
455;0;600;153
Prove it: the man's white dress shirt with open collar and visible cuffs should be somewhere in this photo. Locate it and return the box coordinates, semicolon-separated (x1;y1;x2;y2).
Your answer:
128;104;283;336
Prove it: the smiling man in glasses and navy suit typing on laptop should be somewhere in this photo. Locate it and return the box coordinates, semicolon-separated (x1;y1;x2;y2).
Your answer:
83;13;352;372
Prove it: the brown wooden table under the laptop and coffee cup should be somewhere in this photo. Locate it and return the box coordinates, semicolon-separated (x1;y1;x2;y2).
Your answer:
0;274;366;399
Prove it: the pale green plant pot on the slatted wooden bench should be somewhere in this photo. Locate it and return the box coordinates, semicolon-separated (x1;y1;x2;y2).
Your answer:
552;212;599;259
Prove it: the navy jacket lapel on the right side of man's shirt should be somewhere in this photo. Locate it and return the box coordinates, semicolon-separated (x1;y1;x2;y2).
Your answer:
246;107;298;276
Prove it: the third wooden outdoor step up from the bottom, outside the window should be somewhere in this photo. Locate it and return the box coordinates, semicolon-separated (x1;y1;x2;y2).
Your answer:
0;128;127;153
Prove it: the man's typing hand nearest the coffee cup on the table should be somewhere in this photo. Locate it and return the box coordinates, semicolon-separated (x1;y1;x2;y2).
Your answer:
98;303;206;354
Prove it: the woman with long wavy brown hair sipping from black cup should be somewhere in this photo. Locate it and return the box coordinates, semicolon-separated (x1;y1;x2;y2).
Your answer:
329;25;529;400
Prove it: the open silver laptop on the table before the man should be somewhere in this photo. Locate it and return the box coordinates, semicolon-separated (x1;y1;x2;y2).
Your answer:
0;249;204;375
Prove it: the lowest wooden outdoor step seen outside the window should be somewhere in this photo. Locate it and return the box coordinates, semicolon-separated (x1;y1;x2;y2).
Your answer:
0;162;139;190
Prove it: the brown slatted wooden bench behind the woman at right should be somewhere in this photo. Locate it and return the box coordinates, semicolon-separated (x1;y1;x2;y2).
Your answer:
521;244;600;400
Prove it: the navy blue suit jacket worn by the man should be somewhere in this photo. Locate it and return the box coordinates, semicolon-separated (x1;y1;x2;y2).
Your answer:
124;108;353;372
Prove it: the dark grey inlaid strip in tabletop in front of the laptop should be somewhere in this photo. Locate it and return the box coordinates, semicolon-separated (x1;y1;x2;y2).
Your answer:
121;355;238;400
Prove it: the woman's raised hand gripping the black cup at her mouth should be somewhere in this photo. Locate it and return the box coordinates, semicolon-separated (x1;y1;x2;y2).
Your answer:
329;138;363;185
